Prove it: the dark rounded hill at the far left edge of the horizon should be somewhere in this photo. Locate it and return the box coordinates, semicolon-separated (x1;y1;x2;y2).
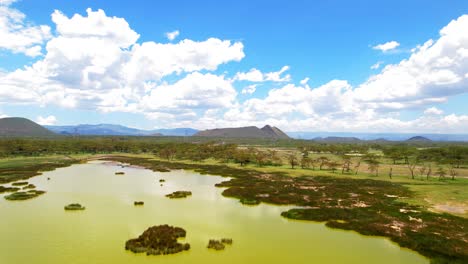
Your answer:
0;117;56;137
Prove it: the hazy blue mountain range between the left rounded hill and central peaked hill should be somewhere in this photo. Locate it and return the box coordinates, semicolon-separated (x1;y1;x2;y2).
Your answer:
46;124;198;136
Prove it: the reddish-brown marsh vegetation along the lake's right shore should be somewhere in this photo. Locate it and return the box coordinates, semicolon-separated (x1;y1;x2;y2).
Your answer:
103;156;468;263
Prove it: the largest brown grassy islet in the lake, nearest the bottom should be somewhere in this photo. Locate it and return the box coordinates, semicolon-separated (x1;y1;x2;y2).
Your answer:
125;225;190;255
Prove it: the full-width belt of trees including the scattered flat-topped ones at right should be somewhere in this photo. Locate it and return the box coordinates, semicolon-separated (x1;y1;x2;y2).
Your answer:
0;137;468;179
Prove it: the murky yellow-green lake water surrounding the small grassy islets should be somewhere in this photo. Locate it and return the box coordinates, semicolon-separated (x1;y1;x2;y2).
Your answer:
0;162;428;264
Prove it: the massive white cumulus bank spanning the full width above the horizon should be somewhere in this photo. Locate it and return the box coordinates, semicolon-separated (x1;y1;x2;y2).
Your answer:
0;5;468;132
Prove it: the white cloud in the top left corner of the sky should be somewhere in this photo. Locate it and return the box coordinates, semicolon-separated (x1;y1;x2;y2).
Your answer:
0;0;51;57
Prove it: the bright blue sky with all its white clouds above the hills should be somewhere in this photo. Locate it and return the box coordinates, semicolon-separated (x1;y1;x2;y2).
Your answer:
0;0;468;134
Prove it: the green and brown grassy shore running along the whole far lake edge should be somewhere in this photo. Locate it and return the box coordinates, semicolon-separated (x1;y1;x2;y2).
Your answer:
0;152;468;263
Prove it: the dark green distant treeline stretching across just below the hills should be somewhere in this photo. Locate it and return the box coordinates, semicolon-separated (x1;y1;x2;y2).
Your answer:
0;137;468;167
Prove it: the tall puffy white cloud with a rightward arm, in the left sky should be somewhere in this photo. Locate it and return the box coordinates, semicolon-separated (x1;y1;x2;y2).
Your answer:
0;9;244;112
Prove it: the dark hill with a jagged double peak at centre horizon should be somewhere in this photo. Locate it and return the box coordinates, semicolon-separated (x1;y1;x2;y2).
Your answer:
194;125;289;139
